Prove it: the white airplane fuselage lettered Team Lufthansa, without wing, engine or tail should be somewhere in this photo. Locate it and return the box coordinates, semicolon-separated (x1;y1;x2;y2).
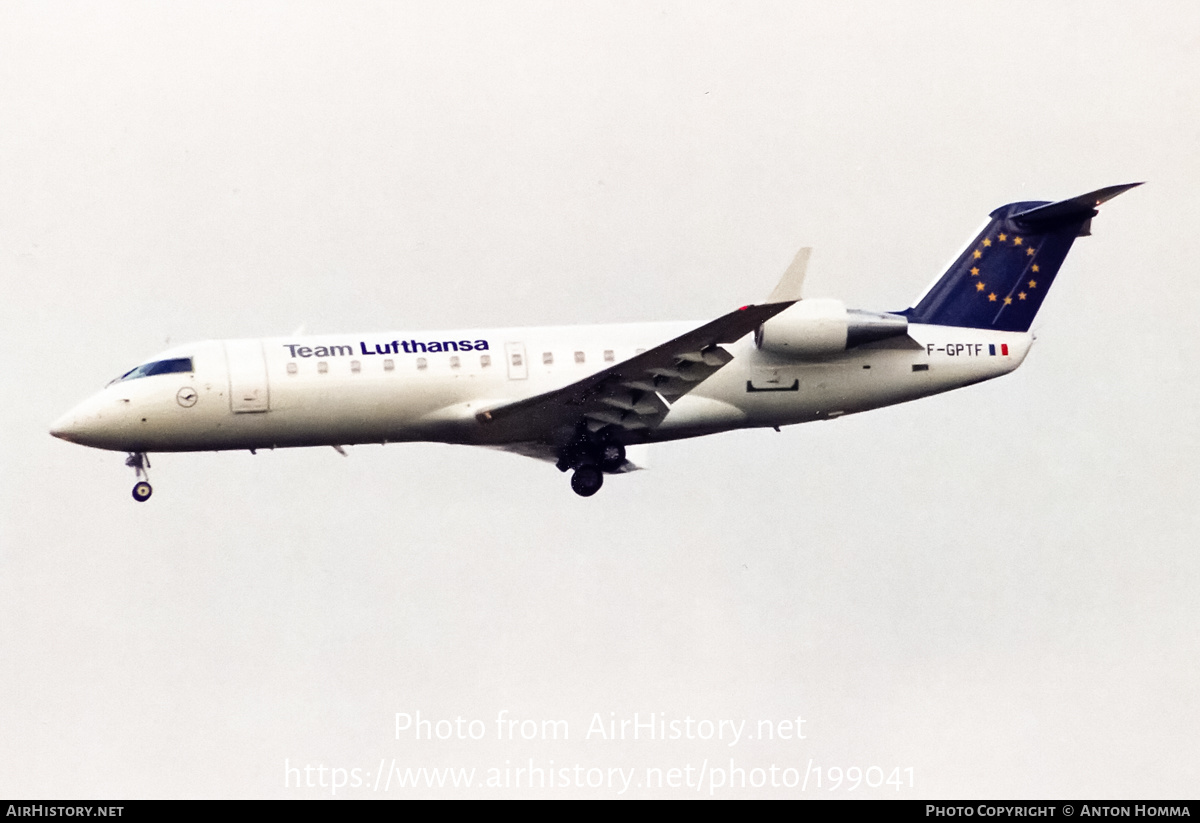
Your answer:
53;323;1032;452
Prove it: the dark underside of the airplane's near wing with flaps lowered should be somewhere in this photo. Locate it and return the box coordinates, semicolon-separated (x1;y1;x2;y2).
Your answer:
475;300;793;441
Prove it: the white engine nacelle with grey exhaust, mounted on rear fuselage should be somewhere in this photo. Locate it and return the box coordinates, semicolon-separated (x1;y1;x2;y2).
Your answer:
754;298;908;359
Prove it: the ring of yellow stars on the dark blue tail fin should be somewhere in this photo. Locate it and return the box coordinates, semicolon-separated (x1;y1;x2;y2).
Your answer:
966;232;1045;325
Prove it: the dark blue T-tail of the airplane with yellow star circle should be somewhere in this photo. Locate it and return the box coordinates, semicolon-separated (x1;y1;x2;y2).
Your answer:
899;182;1141;331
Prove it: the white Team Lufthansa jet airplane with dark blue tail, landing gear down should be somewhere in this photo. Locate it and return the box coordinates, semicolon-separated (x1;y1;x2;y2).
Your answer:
50;184;1141;501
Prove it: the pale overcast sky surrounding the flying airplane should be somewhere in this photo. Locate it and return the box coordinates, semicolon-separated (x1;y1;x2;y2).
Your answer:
0;2;1200;798
